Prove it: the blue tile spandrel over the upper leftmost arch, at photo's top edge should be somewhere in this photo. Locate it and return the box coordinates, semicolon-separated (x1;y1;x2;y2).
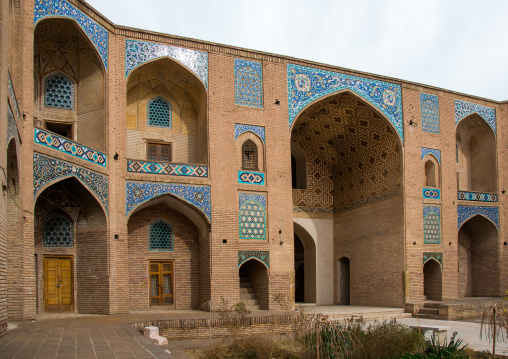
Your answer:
34;0;108;70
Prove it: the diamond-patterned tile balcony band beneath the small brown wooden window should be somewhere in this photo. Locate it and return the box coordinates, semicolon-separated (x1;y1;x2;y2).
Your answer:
127;160;208;177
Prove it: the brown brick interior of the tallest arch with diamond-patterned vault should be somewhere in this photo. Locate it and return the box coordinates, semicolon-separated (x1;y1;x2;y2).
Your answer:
291;91;404;307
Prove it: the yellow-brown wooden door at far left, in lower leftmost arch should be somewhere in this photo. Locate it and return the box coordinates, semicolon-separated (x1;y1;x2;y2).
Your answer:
44;257;73;311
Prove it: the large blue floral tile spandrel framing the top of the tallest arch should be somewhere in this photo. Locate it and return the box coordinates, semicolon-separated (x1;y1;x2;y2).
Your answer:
287;64;404;143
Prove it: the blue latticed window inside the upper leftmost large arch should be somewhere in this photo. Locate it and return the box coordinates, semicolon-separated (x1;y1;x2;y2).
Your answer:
44;74;74;110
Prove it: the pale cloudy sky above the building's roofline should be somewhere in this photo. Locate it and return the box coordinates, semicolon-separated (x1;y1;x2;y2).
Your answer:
85;0;508;101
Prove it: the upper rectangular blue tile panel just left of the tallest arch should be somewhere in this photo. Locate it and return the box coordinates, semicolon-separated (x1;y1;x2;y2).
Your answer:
235;59;263;107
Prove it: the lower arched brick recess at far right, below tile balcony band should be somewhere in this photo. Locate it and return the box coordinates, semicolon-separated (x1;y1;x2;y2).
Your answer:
458;215;501;297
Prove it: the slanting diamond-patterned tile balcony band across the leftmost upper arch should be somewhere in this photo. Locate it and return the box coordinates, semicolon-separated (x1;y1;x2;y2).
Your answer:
35;128;106;167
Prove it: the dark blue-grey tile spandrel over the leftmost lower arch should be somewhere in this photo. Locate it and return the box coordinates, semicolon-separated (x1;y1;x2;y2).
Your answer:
34;153;108;211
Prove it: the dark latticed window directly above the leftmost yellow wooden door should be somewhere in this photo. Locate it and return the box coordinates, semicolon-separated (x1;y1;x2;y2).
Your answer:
42;212;74;247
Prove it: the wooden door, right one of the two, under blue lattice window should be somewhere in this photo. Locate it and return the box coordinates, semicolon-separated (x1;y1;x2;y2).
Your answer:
149;261;173;306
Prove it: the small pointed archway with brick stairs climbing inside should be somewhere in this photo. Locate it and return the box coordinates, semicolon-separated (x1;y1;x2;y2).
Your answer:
238;259;270;310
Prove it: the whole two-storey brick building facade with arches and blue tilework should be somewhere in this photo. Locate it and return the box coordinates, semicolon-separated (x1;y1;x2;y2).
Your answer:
0;0;508;338
